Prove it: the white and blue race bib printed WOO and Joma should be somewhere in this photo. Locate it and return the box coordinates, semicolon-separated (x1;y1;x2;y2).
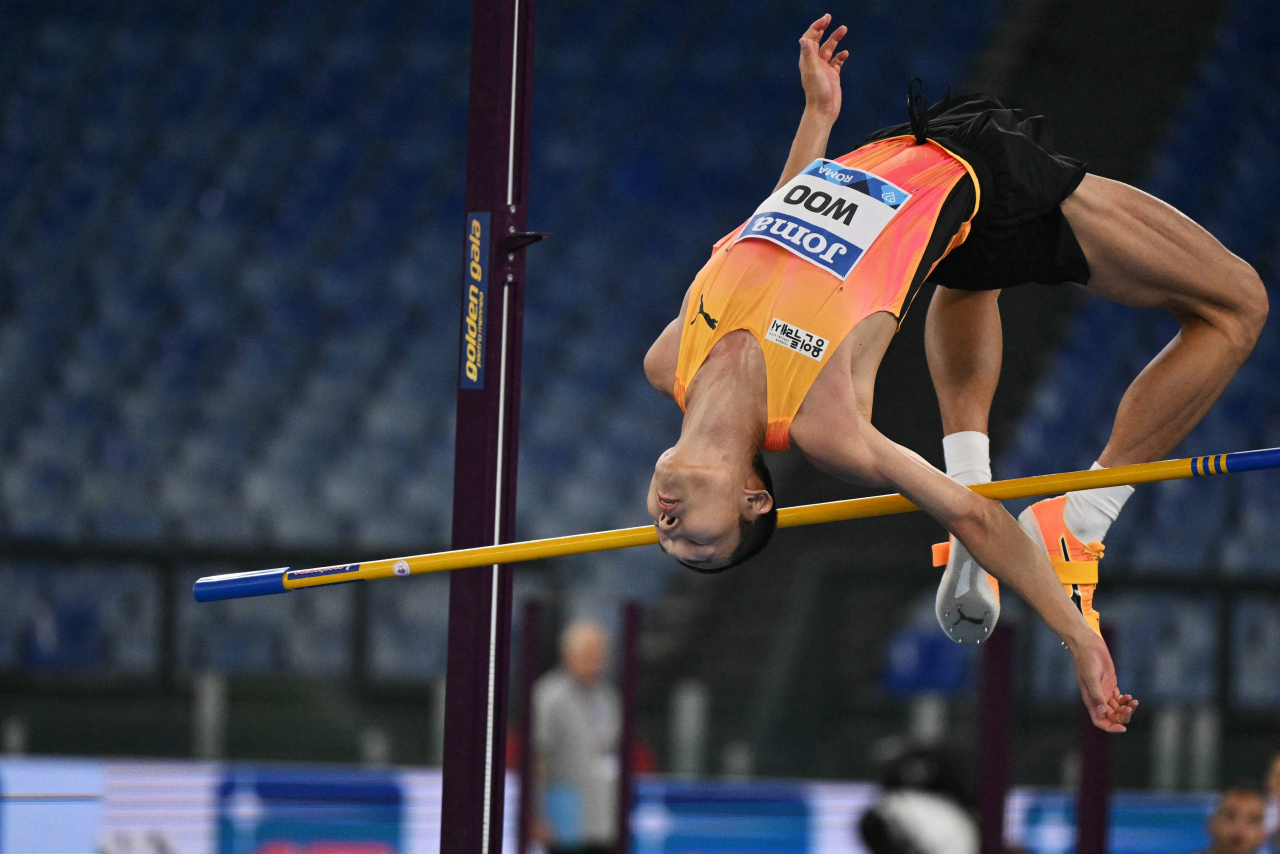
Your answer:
735;160;911;279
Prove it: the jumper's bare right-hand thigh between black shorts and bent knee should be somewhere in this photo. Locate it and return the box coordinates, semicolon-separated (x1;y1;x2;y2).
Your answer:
1062;175;1256;316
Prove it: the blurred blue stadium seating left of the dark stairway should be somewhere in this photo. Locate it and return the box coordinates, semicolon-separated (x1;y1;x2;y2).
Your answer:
0;0;1000;676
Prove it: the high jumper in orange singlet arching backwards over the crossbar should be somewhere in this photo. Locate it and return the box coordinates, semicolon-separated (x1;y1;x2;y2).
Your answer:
644;15;1267;731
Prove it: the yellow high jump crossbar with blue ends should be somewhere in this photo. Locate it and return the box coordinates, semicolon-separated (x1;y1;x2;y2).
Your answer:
192;448;1280;602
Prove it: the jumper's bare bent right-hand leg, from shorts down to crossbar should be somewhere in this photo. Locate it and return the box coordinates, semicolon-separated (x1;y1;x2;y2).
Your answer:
1062;175;1267;466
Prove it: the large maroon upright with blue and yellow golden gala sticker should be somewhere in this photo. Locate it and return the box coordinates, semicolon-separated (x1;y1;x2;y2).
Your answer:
440;0;536;854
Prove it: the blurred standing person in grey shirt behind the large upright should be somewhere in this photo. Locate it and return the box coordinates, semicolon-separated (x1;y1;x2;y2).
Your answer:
534;621;622;854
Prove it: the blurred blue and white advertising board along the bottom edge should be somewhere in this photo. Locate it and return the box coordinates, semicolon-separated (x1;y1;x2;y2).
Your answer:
0;763;1215;854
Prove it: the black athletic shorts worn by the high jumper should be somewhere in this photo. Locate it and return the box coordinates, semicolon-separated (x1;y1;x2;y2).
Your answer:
861;95;1089;291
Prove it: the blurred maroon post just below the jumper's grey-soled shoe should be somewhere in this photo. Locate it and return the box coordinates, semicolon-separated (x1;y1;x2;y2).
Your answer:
978;626;1016;854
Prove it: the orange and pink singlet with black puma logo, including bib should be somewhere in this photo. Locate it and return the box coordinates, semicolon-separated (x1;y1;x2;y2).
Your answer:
675;137;978;451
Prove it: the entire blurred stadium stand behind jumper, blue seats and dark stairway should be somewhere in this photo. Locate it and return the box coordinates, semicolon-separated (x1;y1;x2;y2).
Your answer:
0;0;1280;786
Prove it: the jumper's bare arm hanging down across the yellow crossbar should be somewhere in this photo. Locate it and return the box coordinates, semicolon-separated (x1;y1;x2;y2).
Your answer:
791;406;1138;732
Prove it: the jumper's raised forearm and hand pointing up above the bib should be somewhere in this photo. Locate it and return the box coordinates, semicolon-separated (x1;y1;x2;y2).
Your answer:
774;14;849;189
